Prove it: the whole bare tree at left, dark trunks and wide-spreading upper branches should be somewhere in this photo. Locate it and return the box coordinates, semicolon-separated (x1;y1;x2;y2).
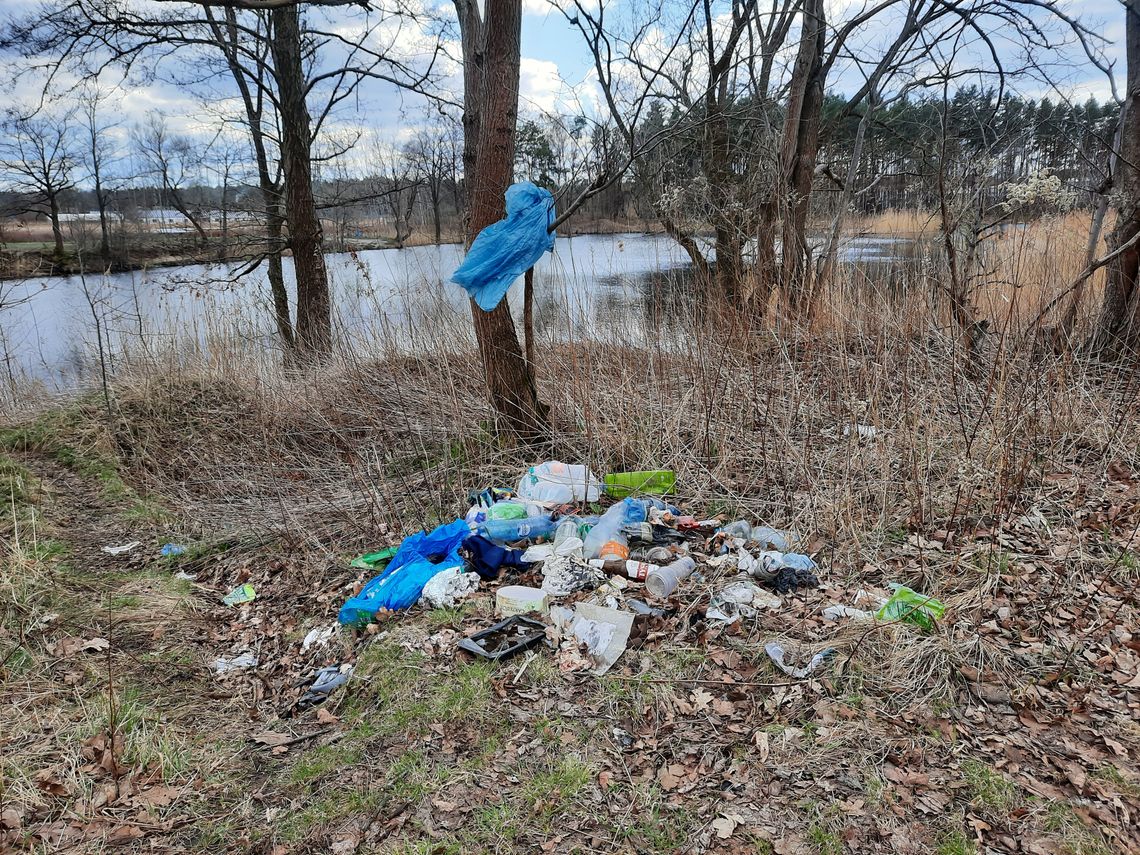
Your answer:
0;0;441;360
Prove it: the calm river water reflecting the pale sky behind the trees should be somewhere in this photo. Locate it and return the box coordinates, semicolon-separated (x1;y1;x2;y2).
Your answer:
0;234;898;390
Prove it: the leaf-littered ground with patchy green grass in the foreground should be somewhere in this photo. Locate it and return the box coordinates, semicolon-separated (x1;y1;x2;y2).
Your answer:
0;383;1140;855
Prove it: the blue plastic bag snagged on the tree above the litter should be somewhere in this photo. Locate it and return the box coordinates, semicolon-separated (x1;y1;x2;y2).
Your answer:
451;181;554;311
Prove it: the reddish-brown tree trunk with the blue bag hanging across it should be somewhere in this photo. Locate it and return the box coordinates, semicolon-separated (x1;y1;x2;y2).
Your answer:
461;0;549;439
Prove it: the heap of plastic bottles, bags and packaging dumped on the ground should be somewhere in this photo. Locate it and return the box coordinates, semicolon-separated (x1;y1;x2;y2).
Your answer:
330;461;945;678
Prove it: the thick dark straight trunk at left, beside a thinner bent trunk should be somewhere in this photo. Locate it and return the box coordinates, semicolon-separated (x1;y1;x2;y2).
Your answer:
270;6;333;359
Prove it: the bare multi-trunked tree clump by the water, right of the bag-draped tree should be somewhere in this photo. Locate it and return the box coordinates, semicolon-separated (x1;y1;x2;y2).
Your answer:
564;0;1091;316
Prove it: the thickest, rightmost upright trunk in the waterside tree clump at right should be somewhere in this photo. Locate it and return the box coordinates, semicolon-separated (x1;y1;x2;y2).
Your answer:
782;0;825;315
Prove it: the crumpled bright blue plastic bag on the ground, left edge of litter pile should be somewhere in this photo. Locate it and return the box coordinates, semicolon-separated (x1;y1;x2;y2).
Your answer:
336;520;471;626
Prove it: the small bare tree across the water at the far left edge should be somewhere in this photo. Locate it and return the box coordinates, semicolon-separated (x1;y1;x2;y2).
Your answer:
0;109;78;259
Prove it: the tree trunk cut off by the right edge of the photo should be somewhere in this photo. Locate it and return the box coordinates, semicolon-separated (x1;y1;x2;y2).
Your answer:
1091;0;1140;357
